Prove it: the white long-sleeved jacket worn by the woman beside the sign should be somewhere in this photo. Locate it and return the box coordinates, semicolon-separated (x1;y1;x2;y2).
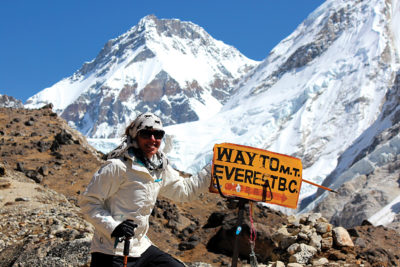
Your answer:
80;156;211;257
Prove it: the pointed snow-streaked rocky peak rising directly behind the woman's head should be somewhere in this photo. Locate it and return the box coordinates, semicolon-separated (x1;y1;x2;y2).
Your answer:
25;15;258;138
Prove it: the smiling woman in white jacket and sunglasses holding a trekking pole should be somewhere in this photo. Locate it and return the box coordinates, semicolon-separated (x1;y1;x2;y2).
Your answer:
80;113;211;267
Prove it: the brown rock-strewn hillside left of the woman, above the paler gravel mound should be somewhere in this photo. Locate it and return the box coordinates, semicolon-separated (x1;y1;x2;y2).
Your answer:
0;108;101;199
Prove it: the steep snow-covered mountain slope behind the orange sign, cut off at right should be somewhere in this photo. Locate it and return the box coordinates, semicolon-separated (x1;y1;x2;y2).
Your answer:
163;0;400;222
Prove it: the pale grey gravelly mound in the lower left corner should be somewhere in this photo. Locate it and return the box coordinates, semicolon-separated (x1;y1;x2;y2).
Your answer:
0;171;93;267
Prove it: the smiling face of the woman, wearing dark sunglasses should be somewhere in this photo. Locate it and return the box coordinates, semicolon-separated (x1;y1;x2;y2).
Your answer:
136;130;164;159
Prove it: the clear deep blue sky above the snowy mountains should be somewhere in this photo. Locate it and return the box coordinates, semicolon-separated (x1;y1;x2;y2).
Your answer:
0;0;324;102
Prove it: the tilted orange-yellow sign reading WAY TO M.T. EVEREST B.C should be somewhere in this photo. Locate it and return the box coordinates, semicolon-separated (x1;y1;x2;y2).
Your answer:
210;143;303;209
